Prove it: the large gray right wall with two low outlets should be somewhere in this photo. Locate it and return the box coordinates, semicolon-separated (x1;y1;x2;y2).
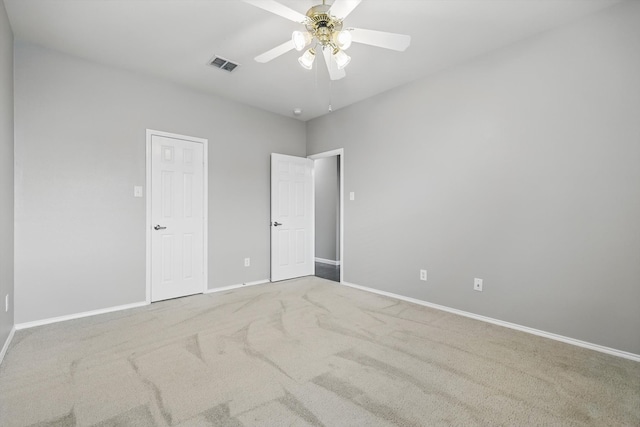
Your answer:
307;1;640;354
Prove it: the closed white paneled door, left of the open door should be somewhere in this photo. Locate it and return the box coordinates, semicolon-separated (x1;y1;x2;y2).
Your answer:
151;135;205;301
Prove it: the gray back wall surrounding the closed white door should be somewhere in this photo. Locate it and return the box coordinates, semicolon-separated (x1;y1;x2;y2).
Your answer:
14;43;306;323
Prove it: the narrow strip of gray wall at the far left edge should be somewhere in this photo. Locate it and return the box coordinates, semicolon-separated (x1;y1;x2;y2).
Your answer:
0;1;14;349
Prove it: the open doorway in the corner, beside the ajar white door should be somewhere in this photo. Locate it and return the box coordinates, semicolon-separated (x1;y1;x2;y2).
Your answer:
309;149;344;282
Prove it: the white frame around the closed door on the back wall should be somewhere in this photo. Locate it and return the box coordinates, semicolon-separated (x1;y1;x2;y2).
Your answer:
144;129;209;304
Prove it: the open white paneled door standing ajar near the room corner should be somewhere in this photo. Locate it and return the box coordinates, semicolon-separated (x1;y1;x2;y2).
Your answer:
271;154;315;282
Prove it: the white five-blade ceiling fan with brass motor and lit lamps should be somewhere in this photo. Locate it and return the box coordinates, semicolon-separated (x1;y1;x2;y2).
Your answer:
243;0;411;80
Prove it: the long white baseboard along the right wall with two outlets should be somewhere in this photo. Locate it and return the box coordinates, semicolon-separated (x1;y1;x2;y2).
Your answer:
342;282;640;362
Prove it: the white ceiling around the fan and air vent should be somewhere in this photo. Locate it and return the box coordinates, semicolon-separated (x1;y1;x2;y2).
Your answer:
4;0;620;120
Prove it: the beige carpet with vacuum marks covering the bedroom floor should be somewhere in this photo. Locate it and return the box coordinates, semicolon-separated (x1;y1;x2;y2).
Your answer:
0;277;640;427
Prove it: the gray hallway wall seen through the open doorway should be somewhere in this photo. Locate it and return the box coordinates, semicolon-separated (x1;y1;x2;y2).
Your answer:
314;156;340;261
